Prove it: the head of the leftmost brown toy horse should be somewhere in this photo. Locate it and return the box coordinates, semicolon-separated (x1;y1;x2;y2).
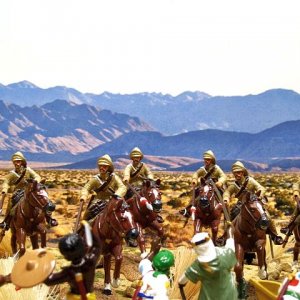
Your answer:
25;180;55;213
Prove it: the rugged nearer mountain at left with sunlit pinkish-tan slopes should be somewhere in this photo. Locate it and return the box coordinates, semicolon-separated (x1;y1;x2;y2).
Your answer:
0;100;152;154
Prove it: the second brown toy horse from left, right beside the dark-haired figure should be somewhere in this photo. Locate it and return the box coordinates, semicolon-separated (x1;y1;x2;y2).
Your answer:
92;198;138;295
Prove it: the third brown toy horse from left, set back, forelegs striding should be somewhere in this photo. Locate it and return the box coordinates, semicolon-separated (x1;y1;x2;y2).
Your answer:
127;179;166;255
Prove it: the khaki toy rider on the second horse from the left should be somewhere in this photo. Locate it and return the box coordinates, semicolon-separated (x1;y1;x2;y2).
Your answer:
80;154;127;220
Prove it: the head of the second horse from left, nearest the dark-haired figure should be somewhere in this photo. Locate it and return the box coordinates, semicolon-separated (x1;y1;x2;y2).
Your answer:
105;198;139;247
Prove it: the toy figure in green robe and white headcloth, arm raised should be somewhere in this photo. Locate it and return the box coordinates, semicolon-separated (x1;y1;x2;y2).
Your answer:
178;228;237;300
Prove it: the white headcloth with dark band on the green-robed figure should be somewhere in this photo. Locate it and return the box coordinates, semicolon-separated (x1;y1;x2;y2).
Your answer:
191;232;217;262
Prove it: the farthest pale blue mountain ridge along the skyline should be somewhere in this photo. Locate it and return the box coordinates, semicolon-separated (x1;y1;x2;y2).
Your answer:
0;81;300;135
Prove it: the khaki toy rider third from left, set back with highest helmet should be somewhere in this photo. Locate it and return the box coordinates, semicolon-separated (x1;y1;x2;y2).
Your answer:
123;147;153;199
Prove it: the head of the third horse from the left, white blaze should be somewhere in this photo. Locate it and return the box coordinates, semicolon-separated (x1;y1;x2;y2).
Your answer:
141;179;162;213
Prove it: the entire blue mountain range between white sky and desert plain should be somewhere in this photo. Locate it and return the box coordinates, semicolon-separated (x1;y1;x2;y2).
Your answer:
0;81;300;170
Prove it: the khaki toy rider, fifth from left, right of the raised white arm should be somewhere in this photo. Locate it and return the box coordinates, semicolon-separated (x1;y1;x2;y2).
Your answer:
223;161;283;245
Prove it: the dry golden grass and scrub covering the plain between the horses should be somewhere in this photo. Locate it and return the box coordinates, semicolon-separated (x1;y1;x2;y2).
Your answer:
0;170;299;299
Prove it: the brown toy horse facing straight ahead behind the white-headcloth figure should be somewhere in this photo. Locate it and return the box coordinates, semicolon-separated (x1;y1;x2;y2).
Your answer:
180;181;223;244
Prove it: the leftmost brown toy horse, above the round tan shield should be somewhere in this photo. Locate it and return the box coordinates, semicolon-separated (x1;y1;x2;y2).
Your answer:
10;180;55;256
